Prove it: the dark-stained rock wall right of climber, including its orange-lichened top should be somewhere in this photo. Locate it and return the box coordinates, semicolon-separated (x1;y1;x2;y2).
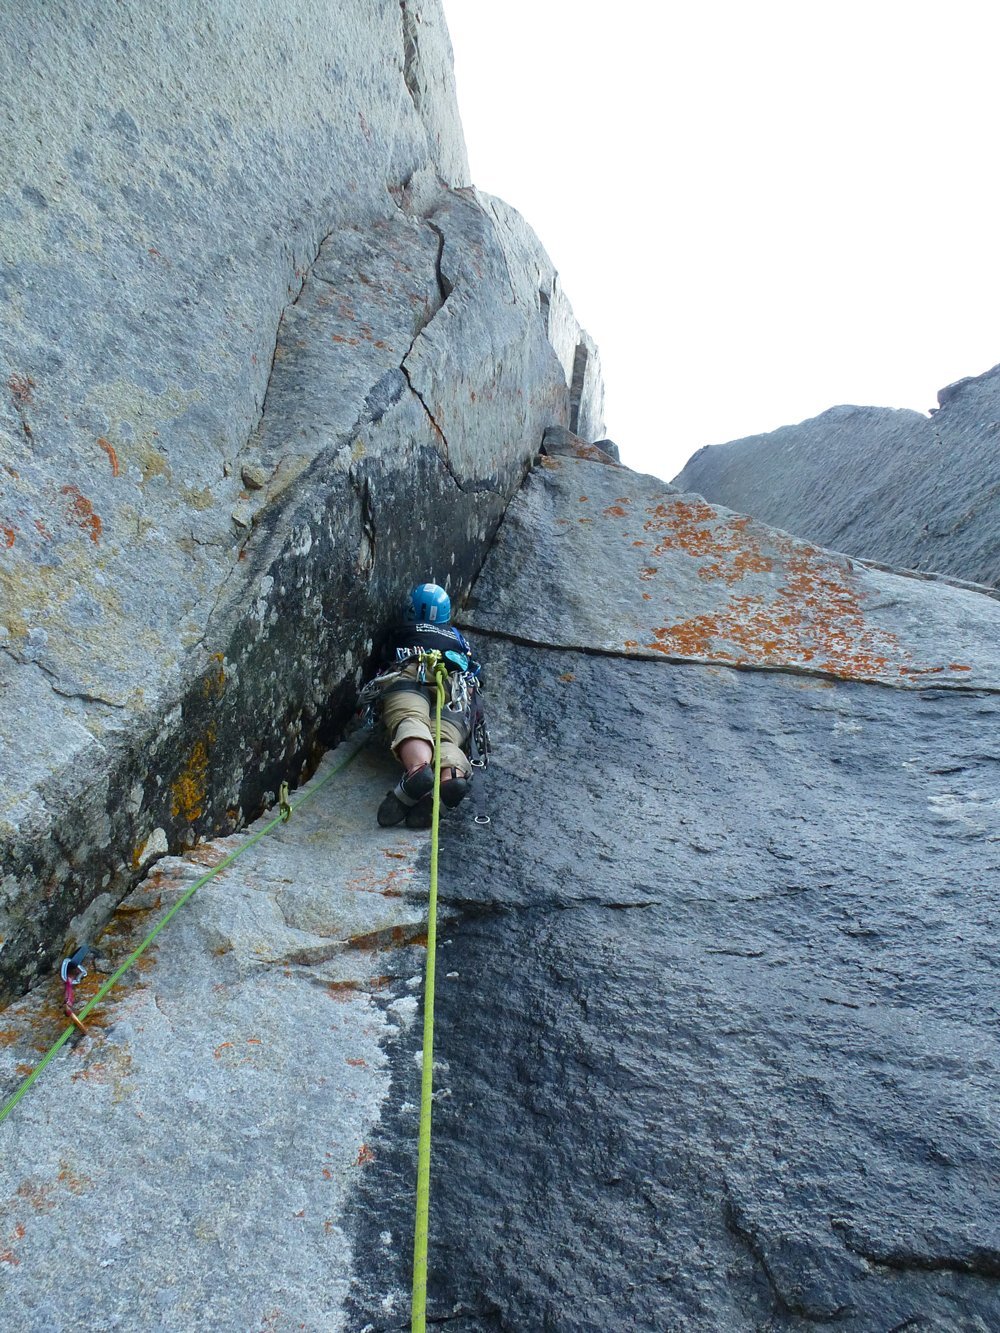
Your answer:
351;455;1000;1333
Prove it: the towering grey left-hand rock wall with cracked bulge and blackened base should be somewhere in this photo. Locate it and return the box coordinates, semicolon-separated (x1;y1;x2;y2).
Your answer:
0;0;600;996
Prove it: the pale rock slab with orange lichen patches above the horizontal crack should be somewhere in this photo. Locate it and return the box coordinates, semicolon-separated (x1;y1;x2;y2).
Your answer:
469;455;1000;689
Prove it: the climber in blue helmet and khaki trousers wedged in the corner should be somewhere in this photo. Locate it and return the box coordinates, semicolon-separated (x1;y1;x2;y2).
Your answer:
361;583;479;829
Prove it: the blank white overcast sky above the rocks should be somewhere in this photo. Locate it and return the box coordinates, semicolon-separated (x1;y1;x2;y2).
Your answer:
444;0;1000;479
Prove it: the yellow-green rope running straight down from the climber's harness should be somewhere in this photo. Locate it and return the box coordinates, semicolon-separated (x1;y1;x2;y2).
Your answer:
409;660;448;1333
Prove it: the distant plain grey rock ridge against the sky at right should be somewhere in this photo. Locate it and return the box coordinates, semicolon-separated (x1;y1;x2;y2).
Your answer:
673;367;1000;587
